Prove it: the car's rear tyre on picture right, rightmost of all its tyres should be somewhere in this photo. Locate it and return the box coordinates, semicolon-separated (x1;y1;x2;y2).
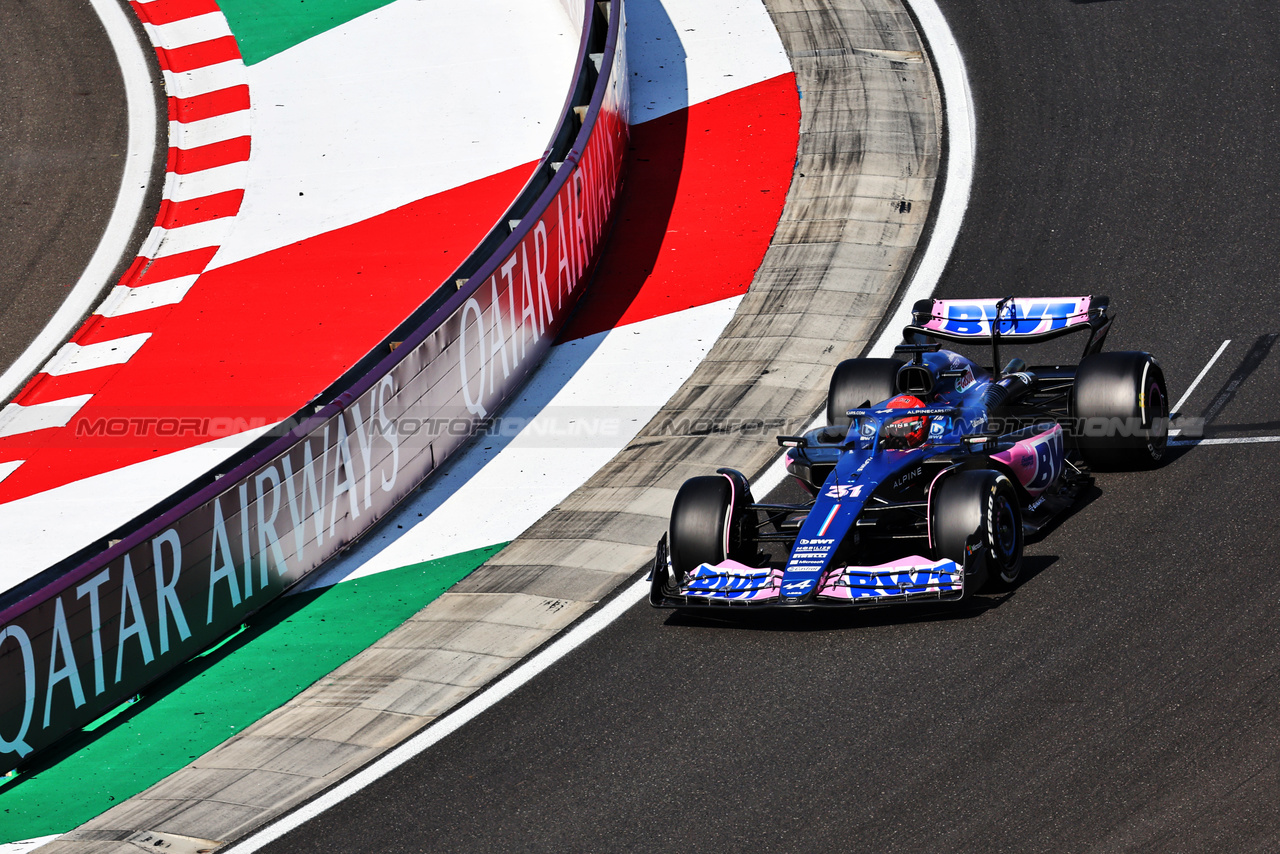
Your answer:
1070;352;1169;471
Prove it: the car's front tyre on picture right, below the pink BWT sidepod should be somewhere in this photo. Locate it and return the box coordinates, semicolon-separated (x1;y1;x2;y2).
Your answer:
929;469;1023;593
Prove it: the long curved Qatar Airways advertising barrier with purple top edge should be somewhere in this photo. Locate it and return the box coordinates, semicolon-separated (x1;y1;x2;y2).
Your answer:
0;0;628;768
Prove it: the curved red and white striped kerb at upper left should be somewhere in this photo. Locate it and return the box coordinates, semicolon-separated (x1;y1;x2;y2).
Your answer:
0;0;251;480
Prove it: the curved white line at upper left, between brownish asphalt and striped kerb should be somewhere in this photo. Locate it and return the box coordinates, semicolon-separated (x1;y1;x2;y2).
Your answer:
0;0;156;399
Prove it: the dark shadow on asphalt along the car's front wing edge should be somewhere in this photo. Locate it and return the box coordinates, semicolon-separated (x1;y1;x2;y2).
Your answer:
664;554;1057;631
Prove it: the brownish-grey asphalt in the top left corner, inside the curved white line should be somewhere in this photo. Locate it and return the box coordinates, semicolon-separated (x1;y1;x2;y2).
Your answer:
0;0;163;391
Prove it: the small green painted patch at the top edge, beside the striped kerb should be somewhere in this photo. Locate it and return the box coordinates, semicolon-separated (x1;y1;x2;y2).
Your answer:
218;0;393;65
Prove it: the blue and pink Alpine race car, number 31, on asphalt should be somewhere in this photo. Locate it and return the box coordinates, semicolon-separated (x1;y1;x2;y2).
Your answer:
649;296;1169;609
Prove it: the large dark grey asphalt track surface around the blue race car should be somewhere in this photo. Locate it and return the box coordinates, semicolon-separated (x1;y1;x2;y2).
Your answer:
177;0;1280;851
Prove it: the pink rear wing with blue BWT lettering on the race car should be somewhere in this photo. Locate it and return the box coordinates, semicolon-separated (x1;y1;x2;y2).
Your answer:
902;296;1111;369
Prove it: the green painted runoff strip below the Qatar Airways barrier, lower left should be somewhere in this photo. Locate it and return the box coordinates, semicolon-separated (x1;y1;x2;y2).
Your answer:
0;544;504;844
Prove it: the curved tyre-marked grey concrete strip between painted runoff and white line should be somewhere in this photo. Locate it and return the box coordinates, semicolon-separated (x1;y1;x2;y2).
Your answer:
41;0;942;853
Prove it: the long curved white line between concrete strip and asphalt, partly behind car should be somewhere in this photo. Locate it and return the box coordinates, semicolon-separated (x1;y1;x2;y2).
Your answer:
227;0;977;854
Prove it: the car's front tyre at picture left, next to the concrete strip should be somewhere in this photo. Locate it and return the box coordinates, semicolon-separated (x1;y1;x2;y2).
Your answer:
667;475;755;585
